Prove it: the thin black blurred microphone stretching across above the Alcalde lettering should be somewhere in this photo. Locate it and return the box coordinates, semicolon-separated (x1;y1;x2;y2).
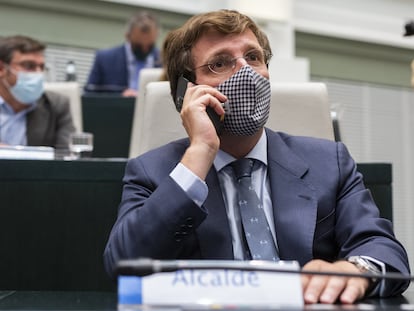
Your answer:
115;258;414;281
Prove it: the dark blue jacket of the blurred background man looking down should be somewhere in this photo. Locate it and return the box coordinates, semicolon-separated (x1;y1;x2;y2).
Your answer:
85;45;160;93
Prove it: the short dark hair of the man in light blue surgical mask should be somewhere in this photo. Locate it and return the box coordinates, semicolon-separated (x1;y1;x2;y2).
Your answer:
0;35;46;64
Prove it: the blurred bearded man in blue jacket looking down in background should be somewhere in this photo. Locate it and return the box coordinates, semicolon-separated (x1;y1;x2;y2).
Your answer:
85;12;161;96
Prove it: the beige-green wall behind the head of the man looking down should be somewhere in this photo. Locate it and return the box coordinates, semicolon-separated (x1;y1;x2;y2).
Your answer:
0;0;187;48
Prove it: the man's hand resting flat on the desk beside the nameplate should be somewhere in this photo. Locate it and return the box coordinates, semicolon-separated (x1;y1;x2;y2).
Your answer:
302;259;369;304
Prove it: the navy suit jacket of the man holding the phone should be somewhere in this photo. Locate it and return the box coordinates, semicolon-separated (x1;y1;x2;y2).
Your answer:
104;129;409;295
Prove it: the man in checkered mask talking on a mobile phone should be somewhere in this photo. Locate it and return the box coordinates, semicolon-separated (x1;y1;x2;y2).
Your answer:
104;10;410;303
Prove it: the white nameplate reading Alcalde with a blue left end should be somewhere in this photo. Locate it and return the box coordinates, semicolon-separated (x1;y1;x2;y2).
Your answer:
118;261;303;308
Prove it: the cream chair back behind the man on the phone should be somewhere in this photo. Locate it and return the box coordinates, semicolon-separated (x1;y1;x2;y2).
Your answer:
130;81;334;157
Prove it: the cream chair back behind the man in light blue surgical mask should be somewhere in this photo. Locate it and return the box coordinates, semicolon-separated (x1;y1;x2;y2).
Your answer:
44;82;83;132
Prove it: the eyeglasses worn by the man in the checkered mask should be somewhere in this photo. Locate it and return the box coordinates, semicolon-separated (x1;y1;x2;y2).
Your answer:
194;50;272;75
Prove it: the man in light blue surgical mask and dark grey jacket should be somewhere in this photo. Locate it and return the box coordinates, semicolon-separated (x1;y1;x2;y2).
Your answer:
0;36;75;149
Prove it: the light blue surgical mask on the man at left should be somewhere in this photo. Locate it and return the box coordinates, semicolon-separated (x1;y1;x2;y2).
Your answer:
10;71;44;104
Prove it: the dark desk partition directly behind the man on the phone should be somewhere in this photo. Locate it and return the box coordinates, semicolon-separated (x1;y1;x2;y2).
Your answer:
0;159;391;291
